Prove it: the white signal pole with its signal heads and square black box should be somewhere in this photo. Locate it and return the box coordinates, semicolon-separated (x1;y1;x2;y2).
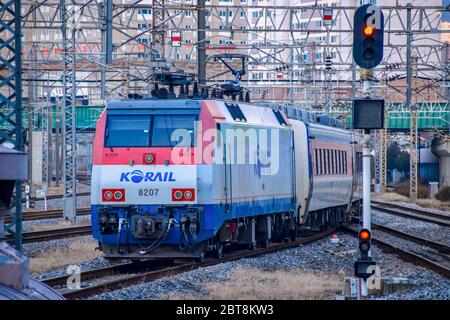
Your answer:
353;4;384;296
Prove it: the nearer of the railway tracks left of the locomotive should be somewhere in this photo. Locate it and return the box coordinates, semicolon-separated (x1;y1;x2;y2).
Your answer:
5;225;92;243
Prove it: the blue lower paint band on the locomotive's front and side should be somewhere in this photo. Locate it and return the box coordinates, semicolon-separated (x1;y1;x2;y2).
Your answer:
91;198;295;245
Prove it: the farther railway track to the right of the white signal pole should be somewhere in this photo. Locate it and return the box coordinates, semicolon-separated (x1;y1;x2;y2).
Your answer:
371;201;450;227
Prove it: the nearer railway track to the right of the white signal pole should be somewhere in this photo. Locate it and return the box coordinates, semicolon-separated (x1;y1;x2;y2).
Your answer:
342;223;450;279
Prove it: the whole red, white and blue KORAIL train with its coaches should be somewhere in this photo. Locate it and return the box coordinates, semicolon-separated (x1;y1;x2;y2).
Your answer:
91;87;362;260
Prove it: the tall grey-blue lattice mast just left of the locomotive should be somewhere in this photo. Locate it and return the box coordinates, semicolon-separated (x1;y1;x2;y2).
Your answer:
60;0;78;221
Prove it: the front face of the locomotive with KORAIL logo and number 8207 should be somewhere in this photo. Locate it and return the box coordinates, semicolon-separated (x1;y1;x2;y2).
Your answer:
91;100;211;259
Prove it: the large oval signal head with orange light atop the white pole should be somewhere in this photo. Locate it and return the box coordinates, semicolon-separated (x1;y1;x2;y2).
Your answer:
353;4;384;69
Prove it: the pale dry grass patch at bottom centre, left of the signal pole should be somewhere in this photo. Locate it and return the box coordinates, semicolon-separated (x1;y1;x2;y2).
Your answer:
163;268;341;300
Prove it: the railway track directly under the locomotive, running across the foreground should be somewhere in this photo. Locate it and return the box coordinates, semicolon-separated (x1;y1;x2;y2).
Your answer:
44;229;336;299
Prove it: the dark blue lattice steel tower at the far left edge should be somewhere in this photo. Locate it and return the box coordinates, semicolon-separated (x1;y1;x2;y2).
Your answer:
0;0;23;250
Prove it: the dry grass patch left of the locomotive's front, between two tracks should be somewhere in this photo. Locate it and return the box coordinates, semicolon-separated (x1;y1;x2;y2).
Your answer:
30;238;102;274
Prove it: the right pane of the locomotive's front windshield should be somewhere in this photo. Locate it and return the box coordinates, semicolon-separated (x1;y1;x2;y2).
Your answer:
151;115;197;147
